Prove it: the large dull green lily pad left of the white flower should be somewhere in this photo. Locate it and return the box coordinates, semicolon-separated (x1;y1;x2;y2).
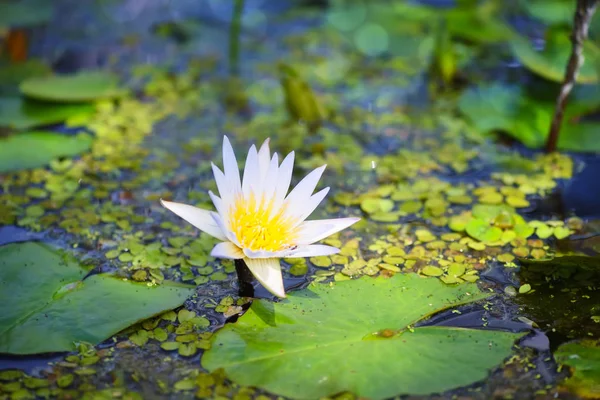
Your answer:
0;242;194;354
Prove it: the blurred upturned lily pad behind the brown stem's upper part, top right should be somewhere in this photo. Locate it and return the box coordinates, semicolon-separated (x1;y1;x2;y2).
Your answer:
510;30;600;84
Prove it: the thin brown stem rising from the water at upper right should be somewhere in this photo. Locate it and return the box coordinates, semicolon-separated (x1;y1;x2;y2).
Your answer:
546;0;599;153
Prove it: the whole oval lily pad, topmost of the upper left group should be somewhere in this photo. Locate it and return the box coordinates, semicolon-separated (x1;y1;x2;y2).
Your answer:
20;71;125;102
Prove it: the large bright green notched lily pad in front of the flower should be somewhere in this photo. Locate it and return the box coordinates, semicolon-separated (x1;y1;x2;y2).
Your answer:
202;274;520;399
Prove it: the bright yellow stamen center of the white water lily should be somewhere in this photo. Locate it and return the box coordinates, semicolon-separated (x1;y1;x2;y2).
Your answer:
229;194;296;251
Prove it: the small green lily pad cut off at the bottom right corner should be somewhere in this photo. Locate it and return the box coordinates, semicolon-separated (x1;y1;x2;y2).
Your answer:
554;340;600;399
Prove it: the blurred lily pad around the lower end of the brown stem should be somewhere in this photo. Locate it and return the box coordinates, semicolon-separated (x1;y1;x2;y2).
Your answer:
458;84;600;151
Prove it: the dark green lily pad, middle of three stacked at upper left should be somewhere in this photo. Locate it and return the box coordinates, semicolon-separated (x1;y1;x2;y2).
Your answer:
0;97;94;130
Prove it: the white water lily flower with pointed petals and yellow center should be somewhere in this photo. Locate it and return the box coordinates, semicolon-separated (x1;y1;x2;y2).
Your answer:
161;136;360;297
